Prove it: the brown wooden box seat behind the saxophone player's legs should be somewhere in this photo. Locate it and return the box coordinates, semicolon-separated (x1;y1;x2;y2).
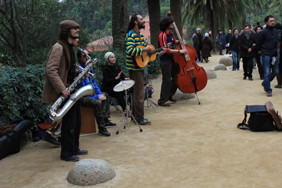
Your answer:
80;106;98;133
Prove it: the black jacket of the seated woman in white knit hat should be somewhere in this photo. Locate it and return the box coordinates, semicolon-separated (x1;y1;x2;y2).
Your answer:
101;64;125;91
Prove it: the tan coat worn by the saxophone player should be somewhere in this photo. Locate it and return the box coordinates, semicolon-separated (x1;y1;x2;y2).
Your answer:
42;40;70;104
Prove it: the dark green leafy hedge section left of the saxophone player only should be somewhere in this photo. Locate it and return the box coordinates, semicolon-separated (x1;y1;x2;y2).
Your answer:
0;64;46;125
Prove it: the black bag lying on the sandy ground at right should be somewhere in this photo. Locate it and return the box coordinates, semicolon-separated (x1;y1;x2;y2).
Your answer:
237;105;276;132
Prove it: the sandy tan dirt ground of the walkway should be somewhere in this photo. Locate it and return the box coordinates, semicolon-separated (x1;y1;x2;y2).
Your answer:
0;51;282;188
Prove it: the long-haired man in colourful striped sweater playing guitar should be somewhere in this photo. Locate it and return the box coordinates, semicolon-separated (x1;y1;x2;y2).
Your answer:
125;14;165;125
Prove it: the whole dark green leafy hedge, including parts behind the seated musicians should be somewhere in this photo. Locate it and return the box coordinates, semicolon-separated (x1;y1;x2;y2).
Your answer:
0;50;160;126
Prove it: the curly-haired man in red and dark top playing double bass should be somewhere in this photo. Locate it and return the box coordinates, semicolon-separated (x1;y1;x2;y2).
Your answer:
158;17;187;107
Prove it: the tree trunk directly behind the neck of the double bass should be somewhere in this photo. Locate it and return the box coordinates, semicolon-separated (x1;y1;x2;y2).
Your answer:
170;0;182;39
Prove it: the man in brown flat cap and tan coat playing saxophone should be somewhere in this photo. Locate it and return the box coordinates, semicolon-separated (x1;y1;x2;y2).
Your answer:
42;20;88;162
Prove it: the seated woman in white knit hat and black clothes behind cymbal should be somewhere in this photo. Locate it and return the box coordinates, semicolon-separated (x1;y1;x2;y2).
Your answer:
101;52;130;115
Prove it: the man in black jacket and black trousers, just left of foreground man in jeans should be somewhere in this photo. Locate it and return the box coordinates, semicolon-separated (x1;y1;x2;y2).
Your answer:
239;25;256;81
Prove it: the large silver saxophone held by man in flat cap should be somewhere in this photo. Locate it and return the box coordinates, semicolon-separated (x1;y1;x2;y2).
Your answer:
47;48;97;121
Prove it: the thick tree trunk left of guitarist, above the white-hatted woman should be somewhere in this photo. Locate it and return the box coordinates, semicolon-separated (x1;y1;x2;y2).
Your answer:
112;0;129;52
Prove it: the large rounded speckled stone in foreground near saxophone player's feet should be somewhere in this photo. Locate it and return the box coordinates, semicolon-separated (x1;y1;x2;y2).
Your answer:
67;159;116;185
